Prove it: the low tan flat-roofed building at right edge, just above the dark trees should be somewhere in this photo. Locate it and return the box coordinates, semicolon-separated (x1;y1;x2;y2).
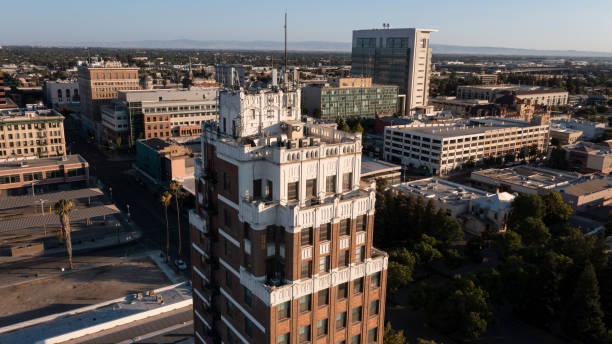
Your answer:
561;175;612;210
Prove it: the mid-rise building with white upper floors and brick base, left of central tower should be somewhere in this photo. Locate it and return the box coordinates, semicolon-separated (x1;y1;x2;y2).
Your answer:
102;87;219;146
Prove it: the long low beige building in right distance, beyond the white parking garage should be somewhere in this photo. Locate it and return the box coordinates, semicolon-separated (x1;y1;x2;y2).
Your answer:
457;84;569;106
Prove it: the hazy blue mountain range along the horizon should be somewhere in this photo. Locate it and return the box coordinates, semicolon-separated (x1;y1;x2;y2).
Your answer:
7;39;612;57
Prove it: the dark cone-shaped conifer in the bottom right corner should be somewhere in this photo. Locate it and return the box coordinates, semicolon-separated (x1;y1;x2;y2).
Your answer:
563;264;607;343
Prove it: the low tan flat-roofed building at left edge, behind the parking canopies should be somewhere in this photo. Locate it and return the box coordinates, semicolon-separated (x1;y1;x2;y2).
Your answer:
0;154;89;197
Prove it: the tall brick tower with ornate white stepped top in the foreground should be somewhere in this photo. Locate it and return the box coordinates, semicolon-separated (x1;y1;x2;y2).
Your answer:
189;91;388;344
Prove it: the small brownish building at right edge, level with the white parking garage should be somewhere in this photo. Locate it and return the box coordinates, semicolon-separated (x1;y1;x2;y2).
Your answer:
563;140;612;173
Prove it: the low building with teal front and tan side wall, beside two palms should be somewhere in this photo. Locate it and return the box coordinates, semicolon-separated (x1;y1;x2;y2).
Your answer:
136;138;194;184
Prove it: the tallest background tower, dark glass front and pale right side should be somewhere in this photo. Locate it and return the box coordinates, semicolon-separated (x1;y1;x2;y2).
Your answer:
351;28;437;114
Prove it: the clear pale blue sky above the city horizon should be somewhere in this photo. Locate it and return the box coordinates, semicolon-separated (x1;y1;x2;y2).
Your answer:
0;0;612;52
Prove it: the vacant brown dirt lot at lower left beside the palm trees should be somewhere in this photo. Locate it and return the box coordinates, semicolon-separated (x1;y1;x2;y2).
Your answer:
0;258;171;326
